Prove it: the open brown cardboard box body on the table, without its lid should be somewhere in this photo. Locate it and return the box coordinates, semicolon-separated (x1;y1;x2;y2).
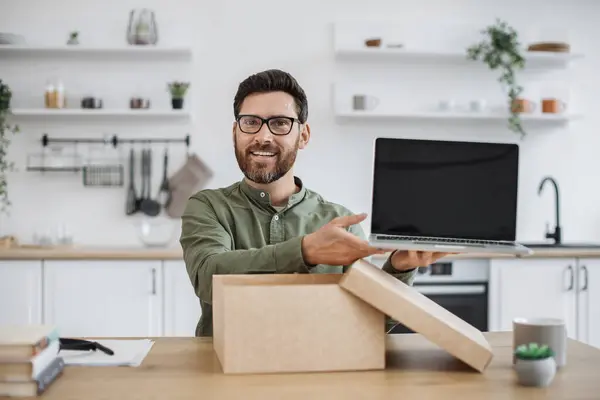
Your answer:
213;274;386;373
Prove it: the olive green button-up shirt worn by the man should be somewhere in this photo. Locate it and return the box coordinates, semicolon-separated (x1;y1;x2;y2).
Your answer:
180;178;416;336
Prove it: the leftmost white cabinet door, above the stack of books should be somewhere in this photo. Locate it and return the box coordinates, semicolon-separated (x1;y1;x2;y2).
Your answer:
0;260;43;325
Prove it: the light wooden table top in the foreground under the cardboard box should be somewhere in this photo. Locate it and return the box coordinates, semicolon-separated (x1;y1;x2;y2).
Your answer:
11;332;600;400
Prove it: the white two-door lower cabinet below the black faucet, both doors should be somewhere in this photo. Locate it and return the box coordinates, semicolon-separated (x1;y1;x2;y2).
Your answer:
490;258;600;347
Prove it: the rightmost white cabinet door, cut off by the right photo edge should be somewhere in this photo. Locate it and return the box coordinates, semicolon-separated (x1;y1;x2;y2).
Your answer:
578;259;600;347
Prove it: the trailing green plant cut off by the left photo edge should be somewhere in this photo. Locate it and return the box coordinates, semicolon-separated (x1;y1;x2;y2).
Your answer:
0;79;19;214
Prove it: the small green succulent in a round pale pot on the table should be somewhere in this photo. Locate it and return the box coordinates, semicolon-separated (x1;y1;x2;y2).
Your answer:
515;343;556;387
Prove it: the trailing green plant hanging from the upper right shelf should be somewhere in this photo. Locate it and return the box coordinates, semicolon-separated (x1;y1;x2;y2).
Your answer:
467;19;525;137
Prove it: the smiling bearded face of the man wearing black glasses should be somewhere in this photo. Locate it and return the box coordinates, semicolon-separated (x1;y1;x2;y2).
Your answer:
233;92;309;184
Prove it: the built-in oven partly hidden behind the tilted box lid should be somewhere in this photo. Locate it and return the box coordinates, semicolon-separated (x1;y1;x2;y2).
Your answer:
389;259;489;334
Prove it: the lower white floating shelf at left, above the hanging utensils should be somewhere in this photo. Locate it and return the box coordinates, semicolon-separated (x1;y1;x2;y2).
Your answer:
11;108;190;118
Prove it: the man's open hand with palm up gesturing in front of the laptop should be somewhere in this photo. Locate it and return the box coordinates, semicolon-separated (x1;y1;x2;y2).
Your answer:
302;214;387;265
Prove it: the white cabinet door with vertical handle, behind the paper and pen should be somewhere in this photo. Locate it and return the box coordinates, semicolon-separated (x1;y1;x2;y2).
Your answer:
44;260;163;337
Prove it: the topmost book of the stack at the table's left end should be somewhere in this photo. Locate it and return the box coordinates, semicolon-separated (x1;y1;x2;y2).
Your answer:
0;325;59;362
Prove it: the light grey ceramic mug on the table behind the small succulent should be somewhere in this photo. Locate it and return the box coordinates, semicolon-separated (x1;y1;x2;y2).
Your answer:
513;318;567;368
